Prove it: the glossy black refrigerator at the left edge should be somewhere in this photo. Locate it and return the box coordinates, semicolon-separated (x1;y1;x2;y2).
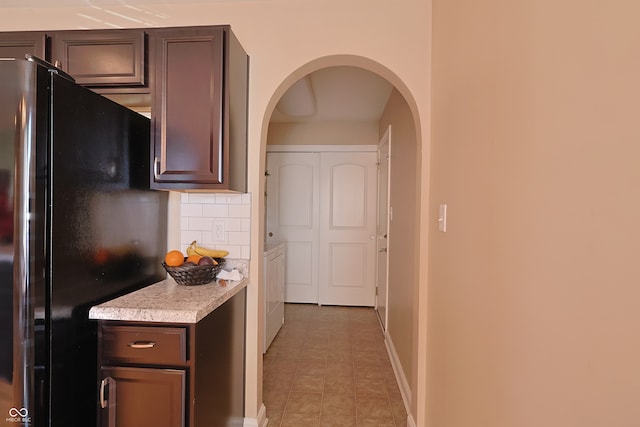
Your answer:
0;58;167;427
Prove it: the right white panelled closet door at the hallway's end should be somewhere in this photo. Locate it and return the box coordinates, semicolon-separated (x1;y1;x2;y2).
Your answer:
318;152;377;307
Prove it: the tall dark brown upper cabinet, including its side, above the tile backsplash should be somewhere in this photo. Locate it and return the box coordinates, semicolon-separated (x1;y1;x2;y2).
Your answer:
149;26;248;192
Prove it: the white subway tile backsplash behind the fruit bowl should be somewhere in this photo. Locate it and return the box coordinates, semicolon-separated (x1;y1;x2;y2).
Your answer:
180;193;251;260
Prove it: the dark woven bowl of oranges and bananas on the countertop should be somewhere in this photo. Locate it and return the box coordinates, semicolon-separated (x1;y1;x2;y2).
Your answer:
162;242;228;286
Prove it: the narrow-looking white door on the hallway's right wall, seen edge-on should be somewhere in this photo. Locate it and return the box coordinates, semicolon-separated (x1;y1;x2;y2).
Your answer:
376;126;391;330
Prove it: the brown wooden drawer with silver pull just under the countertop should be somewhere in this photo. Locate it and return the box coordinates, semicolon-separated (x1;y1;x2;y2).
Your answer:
102;324;187;365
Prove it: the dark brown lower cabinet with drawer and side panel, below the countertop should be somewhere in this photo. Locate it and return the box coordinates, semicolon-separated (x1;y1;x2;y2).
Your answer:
97;289;246;427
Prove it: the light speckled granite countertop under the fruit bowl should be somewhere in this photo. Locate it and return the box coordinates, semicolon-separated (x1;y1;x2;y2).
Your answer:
89;278;248;323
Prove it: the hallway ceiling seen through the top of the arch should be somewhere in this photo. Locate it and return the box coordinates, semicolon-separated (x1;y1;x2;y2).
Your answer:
271;66;393;123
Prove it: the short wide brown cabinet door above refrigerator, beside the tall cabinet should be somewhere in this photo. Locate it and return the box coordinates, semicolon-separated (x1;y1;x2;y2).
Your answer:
51;30;146;87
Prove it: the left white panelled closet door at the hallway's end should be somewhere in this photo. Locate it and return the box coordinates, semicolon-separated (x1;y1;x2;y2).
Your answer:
266;153;320;303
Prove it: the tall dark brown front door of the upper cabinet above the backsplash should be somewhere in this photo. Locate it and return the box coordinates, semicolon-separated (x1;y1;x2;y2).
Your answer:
150;27;228;188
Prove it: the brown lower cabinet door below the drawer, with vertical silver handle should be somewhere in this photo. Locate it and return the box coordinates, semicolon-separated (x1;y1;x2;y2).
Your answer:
101;367;186;427
